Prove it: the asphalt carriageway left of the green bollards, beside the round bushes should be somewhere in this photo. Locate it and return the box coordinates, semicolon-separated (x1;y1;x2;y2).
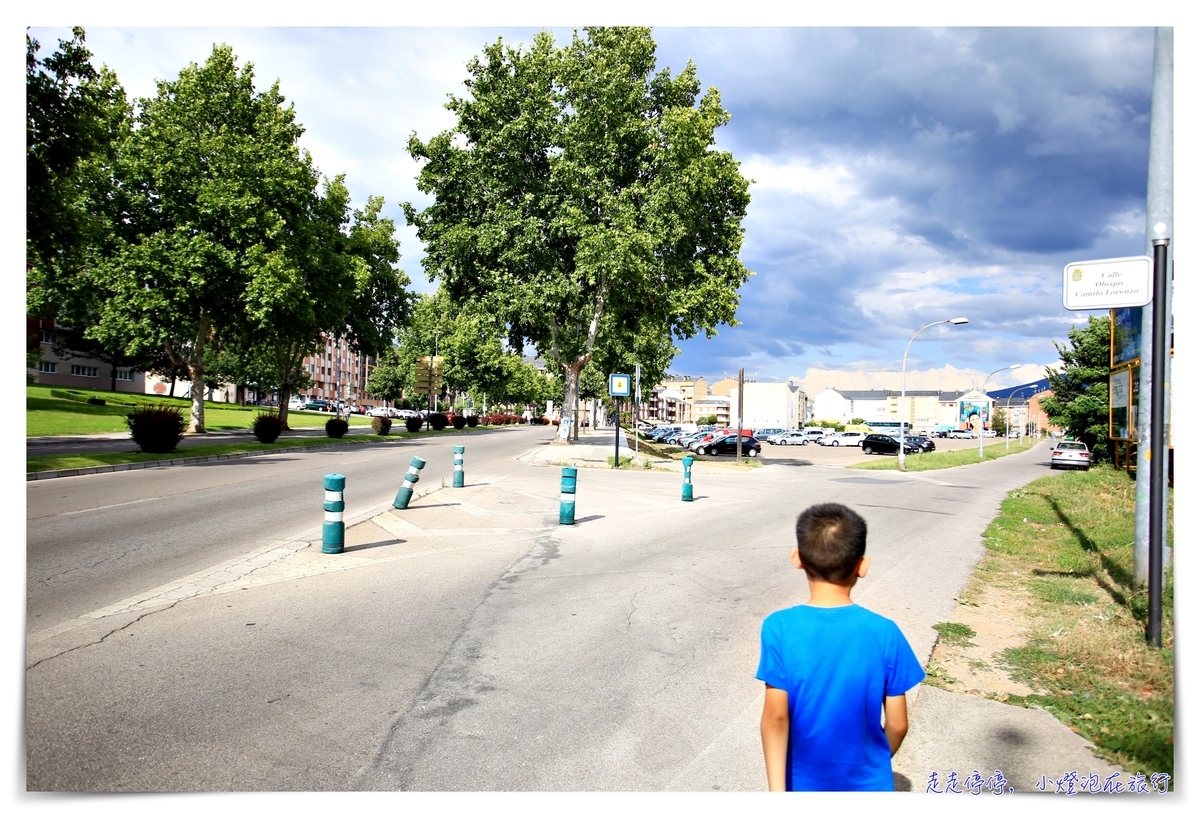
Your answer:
25;426;553;632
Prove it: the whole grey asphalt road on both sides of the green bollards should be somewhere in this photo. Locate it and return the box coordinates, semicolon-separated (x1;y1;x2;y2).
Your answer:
25;429;1051;792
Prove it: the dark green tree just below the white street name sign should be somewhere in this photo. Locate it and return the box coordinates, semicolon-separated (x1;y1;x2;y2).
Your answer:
1042;315;1110;459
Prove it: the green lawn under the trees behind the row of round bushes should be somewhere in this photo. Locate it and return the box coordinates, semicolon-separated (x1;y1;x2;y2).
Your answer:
25;386;371;438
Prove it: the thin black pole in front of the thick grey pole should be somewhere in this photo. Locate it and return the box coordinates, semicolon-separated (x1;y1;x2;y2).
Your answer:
1146;239;1170;648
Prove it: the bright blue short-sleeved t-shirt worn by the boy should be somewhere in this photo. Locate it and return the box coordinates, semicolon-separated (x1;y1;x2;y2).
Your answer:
757;605;925;792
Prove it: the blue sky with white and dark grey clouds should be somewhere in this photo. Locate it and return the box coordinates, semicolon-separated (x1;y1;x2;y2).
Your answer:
23;14;1153;393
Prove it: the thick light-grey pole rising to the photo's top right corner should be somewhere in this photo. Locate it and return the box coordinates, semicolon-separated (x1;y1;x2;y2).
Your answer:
1133;26;1175;584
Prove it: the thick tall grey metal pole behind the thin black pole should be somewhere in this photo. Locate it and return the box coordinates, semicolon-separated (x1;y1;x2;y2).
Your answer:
1133;26;1175;583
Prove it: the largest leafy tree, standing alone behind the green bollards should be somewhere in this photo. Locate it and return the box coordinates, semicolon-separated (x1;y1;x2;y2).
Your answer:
406;28;750;443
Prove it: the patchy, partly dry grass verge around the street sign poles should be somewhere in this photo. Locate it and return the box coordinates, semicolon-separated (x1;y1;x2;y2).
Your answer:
940;468;1175;776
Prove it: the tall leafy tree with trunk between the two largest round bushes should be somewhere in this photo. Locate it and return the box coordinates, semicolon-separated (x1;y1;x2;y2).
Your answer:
83;46;318;432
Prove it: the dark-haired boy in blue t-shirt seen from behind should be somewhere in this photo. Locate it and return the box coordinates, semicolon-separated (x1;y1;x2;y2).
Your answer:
757;503;925;792
